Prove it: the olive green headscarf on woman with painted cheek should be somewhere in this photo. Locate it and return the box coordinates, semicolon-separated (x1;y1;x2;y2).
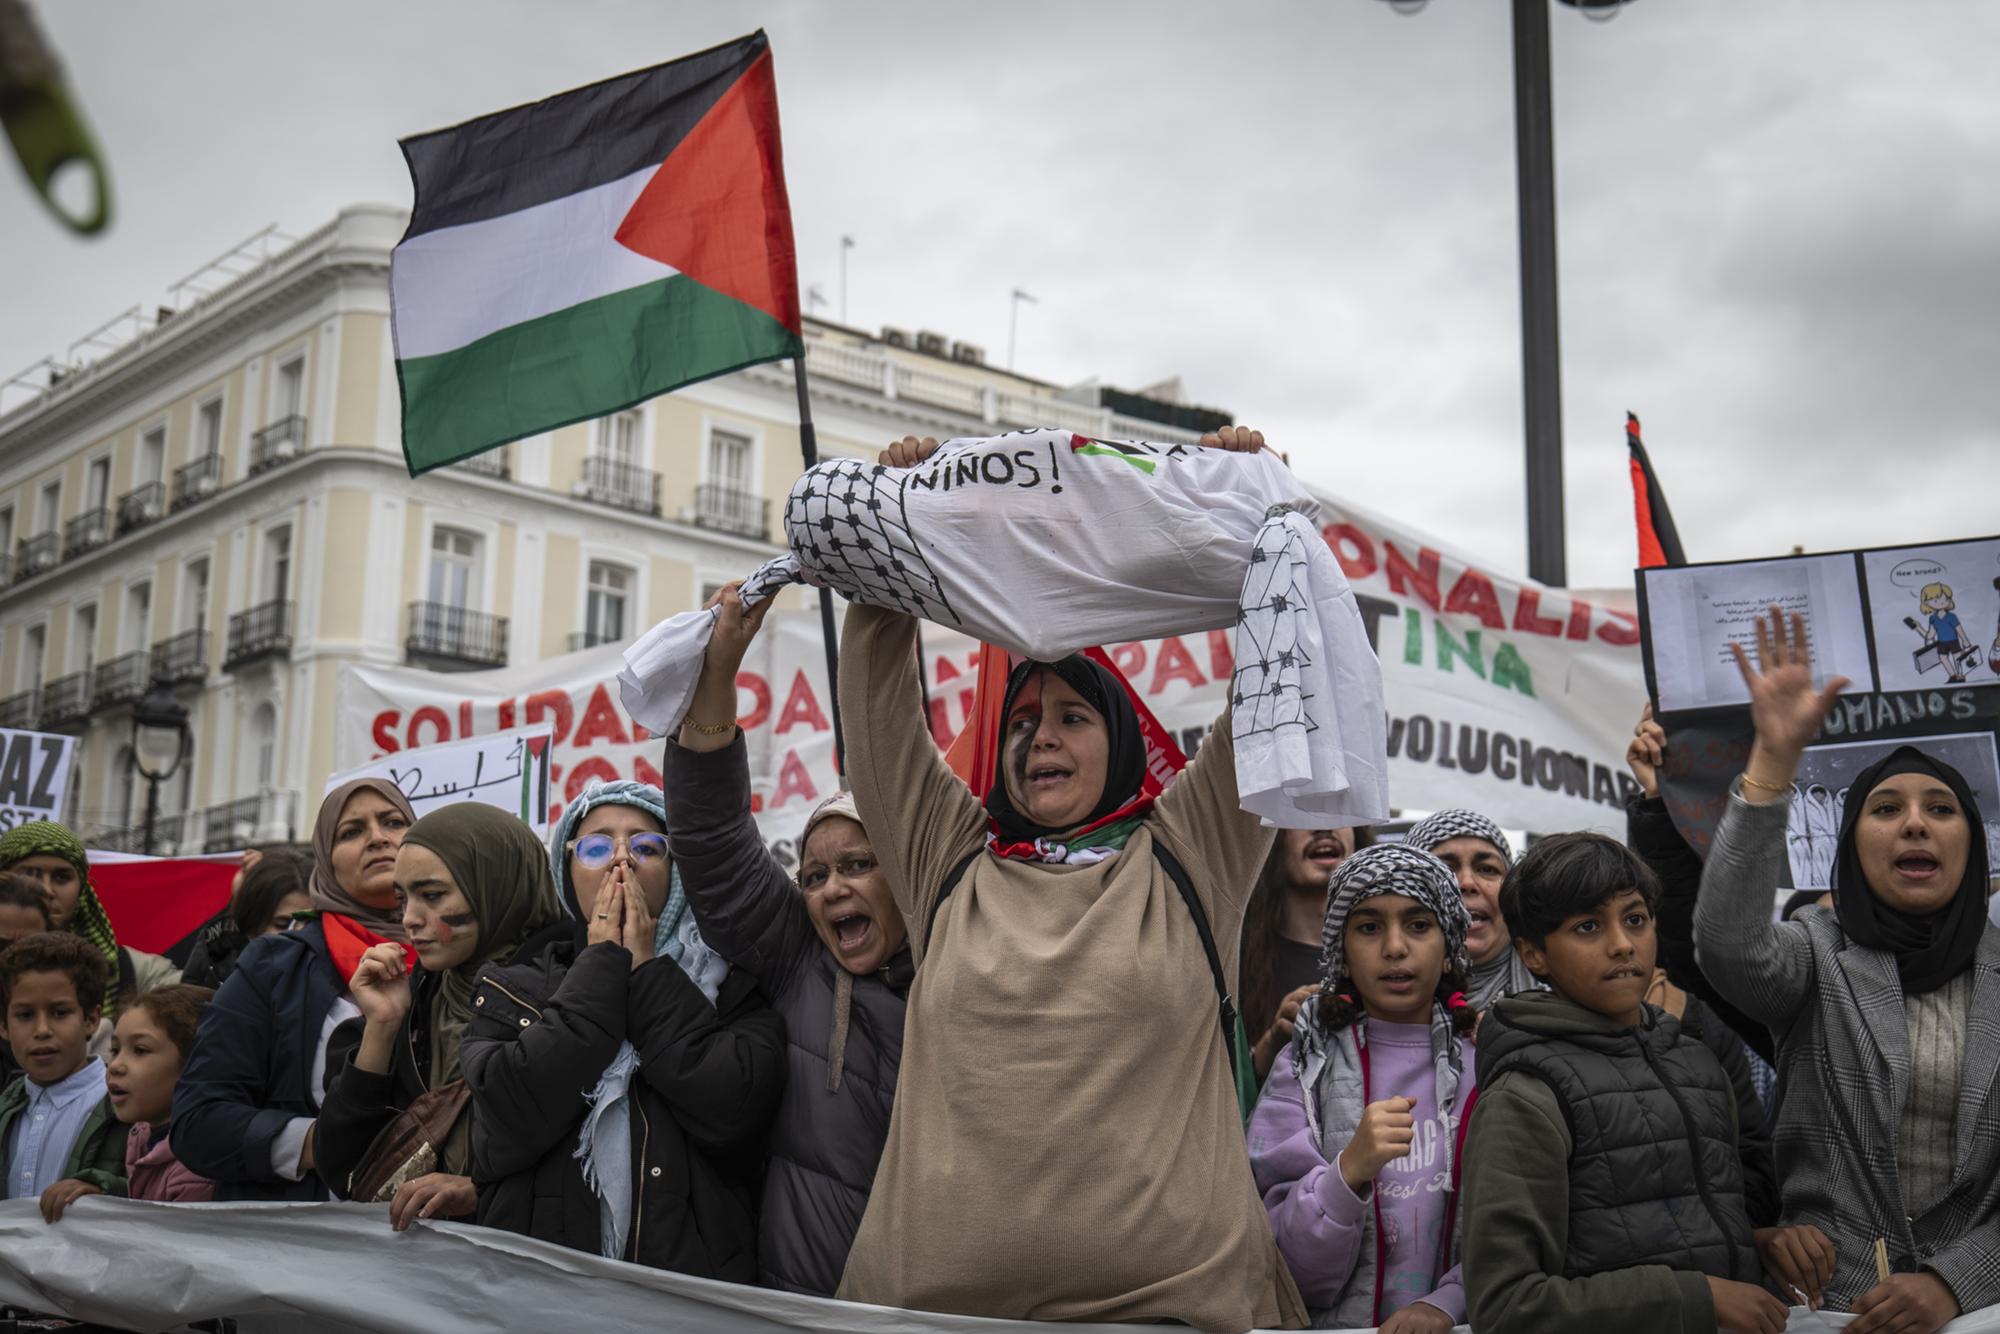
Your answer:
402;802;562;1088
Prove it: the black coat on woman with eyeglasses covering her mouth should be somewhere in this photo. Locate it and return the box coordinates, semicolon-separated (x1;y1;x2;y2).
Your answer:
460;936;784;1284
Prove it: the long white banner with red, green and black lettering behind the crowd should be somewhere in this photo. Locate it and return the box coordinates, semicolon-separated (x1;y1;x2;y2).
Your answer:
334;496;1646;858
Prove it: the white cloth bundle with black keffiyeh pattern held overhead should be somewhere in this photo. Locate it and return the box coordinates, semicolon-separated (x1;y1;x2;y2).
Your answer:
620;430;1388;828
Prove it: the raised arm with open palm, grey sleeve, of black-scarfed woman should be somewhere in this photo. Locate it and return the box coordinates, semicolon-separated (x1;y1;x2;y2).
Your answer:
1694;608;1848;1030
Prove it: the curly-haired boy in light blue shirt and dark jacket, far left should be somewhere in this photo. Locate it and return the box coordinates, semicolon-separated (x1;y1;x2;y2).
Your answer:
0;932;126;1222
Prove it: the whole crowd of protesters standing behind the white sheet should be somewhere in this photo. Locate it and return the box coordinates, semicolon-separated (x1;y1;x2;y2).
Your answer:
0;432;2000;1334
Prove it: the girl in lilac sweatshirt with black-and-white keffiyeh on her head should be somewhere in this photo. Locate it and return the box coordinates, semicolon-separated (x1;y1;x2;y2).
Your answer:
1248;844;1478;1334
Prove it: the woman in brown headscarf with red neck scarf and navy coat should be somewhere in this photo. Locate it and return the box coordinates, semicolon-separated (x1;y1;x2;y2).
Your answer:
172;778;416;1200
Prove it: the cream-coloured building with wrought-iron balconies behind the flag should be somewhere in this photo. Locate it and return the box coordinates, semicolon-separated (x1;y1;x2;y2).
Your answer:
0;206;1214;850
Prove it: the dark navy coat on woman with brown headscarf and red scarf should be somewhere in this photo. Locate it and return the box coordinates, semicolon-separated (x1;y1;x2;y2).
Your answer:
172;922;360;1200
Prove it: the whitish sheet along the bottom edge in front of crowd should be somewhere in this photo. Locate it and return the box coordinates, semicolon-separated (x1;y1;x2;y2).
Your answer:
11;1196;2000;1334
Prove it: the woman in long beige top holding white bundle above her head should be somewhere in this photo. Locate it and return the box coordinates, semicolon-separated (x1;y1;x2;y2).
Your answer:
832;428;1306;1330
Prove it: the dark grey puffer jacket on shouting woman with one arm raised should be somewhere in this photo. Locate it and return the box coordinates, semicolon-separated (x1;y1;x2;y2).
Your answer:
660;732;914;1296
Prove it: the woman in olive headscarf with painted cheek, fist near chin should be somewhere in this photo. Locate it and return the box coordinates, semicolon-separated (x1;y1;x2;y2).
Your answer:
314;802;564;1232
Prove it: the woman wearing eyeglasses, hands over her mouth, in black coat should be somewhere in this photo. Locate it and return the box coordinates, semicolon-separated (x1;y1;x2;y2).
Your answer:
460;782;784;1282
